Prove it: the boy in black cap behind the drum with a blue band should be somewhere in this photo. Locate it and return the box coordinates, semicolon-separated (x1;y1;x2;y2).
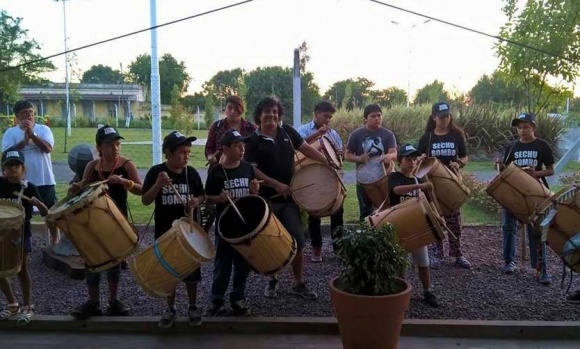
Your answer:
141;131;205;328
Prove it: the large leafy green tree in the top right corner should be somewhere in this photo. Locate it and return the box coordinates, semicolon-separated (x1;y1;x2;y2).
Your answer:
496;0;580;114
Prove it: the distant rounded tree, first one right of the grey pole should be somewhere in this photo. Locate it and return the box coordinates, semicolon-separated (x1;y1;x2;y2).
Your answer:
324;77;375;109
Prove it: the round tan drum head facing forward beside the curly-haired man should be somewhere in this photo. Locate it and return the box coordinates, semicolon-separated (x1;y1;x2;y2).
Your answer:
290;163;342;211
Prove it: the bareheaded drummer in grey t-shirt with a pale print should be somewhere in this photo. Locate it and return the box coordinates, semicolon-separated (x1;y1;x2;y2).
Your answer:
345;104;397;221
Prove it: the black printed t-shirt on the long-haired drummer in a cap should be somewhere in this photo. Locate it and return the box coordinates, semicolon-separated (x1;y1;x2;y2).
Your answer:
417;130;467;166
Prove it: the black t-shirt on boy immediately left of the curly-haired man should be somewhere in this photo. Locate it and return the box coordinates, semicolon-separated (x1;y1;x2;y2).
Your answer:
205;160;256;217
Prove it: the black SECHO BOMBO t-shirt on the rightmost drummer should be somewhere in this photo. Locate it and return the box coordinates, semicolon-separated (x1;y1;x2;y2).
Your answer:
503;138;555;187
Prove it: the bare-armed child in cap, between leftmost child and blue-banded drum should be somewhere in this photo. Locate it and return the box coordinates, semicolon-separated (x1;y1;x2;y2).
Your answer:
69;125;141;320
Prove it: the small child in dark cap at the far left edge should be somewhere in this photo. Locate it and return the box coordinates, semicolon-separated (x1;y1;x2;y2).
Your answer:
0;148;48;325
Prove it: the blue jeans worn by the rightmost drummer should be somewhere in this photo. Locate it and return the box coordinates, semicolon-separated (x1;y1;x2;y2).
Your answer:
501;209;548;273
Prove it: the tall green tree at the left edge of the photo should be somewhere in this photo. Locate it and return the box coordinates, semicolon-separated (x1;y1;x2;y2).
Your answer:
0;10;56;103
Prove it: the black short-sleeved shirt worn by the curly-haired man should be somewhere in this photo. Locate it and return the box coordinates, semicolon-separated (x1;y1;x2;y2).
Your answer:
244;124;304;203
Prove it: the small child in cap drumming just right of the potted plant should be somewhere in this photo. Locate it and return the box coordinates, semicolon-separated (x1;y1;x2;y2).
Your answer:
389;144;438;307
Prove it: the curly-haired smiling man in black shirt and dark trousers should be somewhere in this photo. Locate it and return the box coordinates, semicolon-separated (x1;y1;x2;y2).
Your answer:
244;97;330;299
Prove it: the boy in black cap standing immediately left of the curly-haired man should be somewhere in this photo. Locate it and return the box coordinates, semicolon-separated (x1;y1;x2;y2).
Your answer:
204;130;260;316
